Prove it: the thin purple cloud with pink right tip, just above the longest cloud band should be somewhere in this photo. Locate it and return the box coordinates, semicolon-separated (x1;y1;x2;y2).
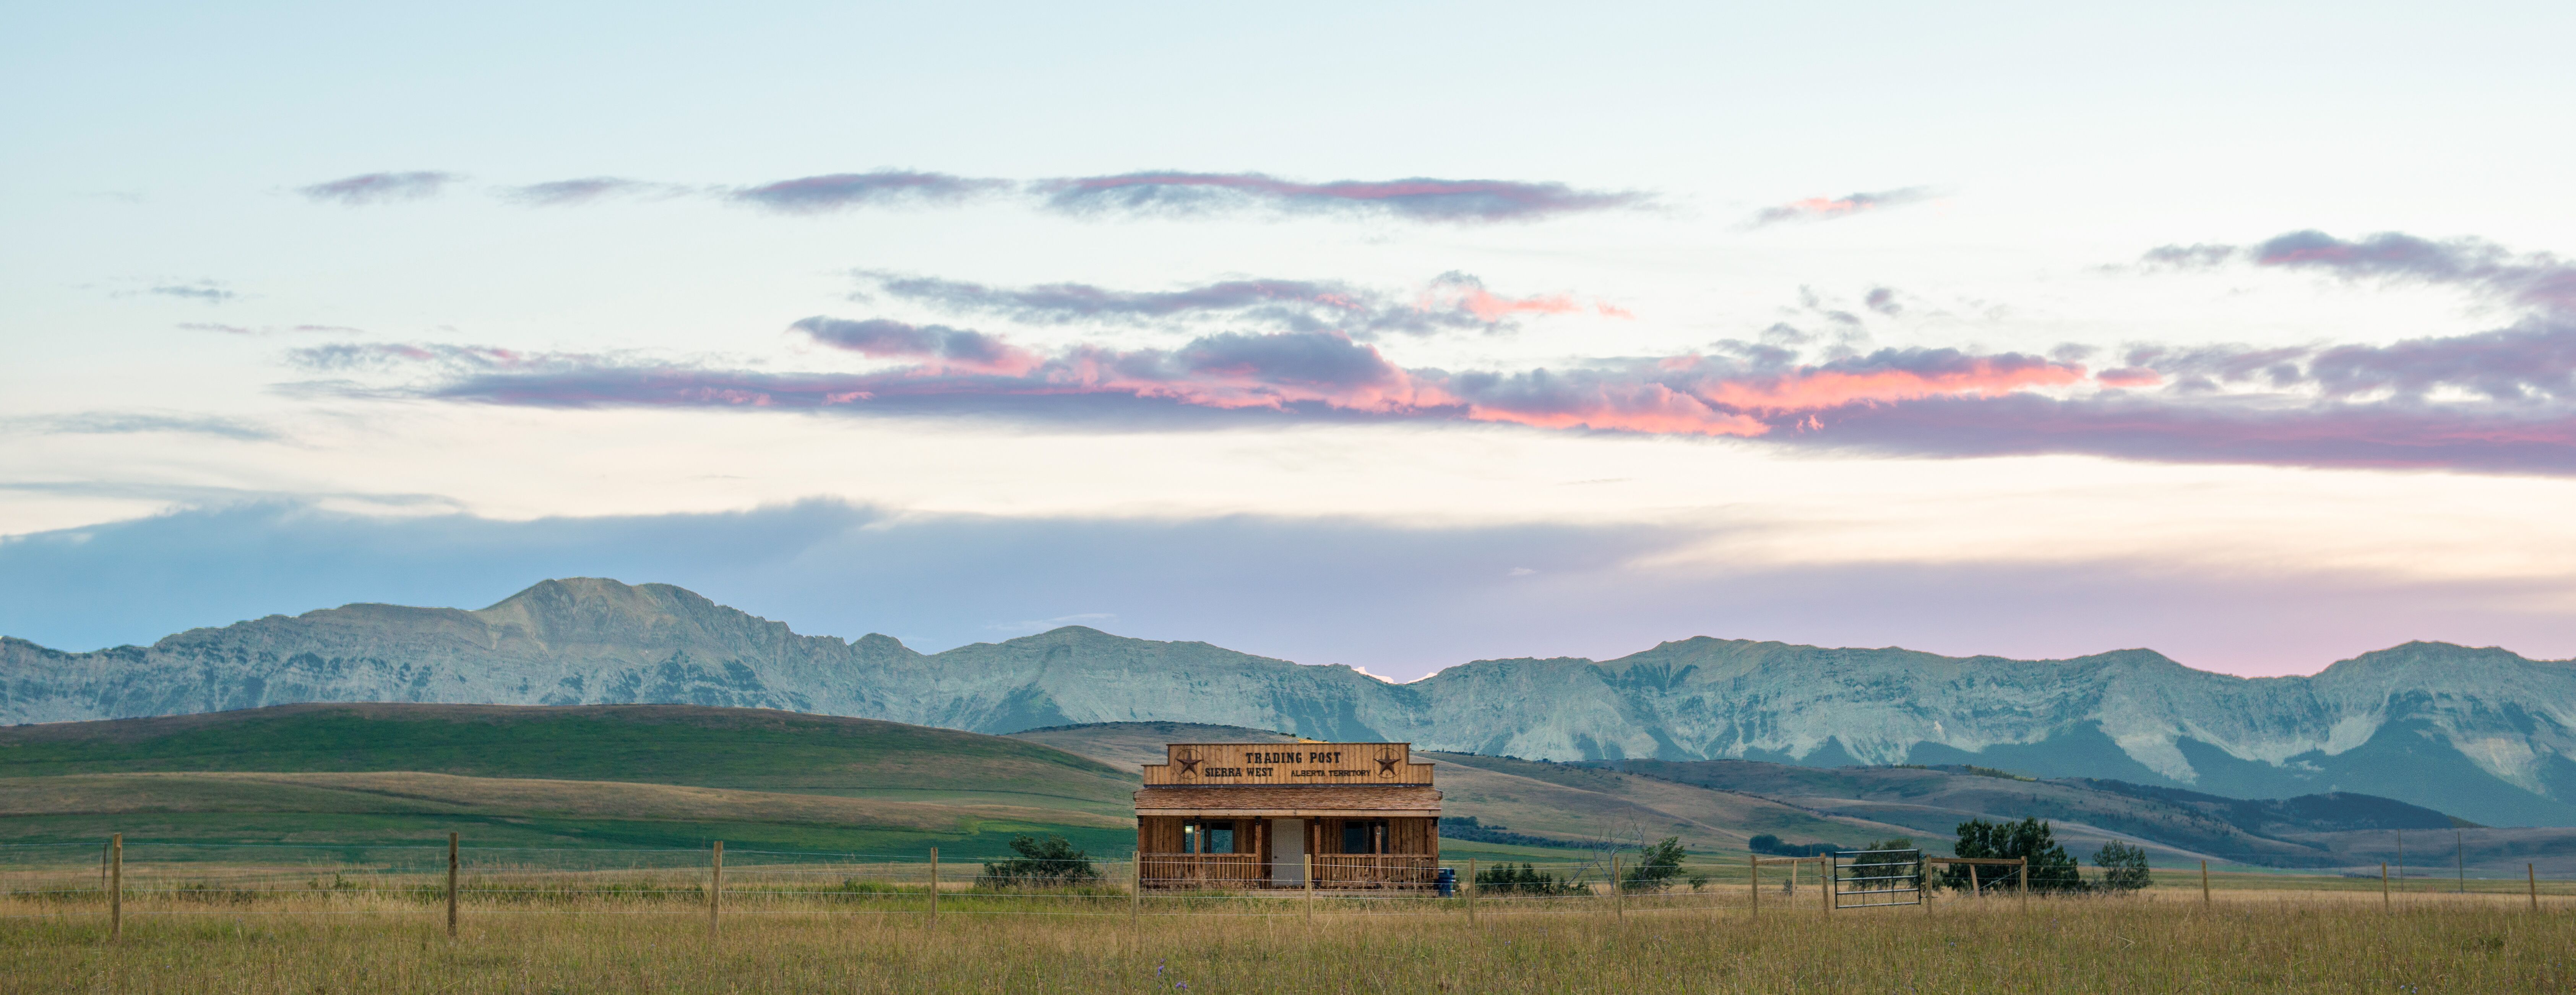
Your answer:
858;271;1636;340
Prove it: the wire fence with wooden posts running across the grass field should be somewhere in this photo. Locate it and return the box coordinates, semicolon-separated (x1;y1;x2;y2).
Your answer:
0;840;2576;930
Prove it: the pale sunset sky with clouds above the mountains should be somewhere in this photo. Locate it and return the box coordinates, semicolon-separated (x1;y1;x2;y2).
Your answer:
0;3;2576;681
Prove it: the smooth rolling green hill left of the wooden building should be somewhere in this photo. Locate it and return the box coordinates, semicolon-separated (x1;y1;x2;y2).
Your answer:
0;704;1136;856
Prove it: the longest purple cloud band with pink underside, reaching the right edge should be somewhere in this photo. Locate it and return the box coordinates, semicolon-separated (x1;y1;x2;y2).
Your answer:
291;301;2576;474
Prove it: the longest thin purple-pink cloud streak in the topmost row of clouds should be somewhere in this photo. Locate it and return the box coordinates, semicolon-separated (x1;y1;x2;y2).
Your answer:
1033;173;1649;222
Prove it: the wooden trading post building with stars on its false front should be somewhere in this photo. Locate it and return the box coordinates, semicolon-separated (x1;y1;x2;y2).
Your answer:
1136;742;1440;889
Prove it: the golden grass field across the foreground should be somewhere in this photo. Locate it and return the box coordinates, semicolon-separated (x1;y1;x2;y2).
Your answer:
0;866;2576;992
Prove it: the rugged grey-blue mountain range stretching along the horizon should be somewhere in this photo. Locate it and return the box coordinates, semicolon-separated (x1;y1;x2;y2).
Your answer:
15;577;2576;825
